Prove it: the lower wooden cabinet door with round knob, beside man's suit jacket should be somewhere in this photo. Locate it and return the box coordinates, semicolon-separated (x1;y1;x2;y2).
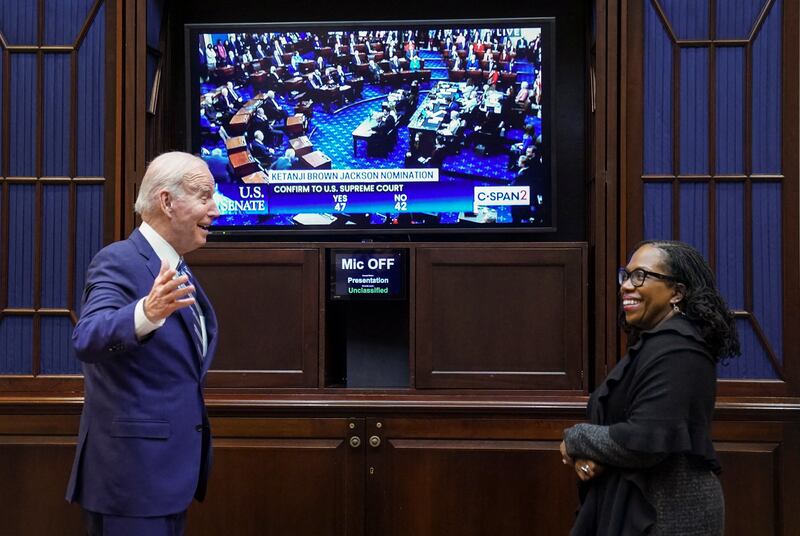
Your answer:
187;418;365;536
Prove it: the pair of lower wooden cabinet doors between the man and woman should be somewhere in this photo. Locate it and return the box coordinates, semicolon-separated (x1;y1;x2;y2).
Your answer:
187;415;575;536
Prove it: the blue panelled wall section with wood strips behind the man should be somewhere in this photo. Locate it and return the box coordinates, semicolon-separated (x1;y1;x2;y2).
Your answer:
0;0;107;375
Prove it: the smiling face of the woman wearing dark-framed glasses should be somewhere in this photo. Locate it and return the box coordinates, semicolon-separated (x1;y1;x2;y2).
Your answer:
619;245;681;330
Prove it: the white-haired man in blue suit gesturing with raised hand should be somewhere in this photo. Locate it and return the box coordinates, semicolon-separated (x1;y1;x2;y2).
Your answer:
66;152;219;536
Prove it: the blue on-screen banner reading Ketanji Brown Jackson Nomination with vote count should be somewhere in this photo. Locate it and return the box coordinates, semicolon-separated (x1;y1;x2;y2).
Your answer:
215;168;531;215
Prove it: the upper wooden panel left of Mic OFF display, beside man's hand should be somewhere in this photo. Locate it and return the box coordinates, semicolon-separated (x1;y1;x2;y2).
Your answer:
188;248;319;387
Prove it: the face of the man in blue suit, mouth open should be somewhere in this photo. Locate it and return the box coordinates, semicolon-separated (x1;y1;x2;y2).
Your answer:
165;166;219;255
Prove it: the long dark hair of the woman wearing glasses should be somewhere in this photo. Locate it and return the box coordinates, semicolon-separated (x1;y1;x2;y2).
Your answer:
622;240;741;361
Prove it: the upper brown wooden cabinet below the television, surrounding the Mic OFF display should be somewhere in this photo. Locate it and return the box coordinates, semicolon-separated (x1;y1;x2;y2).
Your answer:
190;242;588;393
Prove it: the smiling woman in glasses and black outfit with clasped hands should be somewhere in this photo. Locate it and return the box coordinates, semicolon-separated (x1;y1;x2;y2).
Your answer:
561;241;739;536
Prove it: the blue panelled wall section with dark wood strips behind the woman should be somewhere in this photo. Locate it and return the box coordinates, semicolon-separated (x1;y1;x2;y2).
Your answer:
642;0;785;379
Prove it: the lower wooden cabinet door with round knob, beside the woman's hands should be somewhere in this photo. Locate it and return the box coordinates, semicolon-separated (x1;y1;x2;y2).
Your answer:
366;417;578;536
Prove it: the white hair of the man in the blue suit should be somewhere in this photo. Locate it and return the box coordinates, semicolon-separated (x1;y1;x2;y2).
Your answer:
133;151;208;216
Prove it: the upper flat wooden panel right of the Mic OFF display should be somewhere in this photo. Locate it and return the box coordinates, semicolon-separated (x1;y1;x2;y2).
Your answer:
416;244;587;390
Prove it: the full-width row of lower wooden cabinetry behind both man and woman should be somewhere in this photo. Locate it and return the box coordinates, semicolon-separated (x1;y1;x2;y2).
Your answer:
0;408;800;536
